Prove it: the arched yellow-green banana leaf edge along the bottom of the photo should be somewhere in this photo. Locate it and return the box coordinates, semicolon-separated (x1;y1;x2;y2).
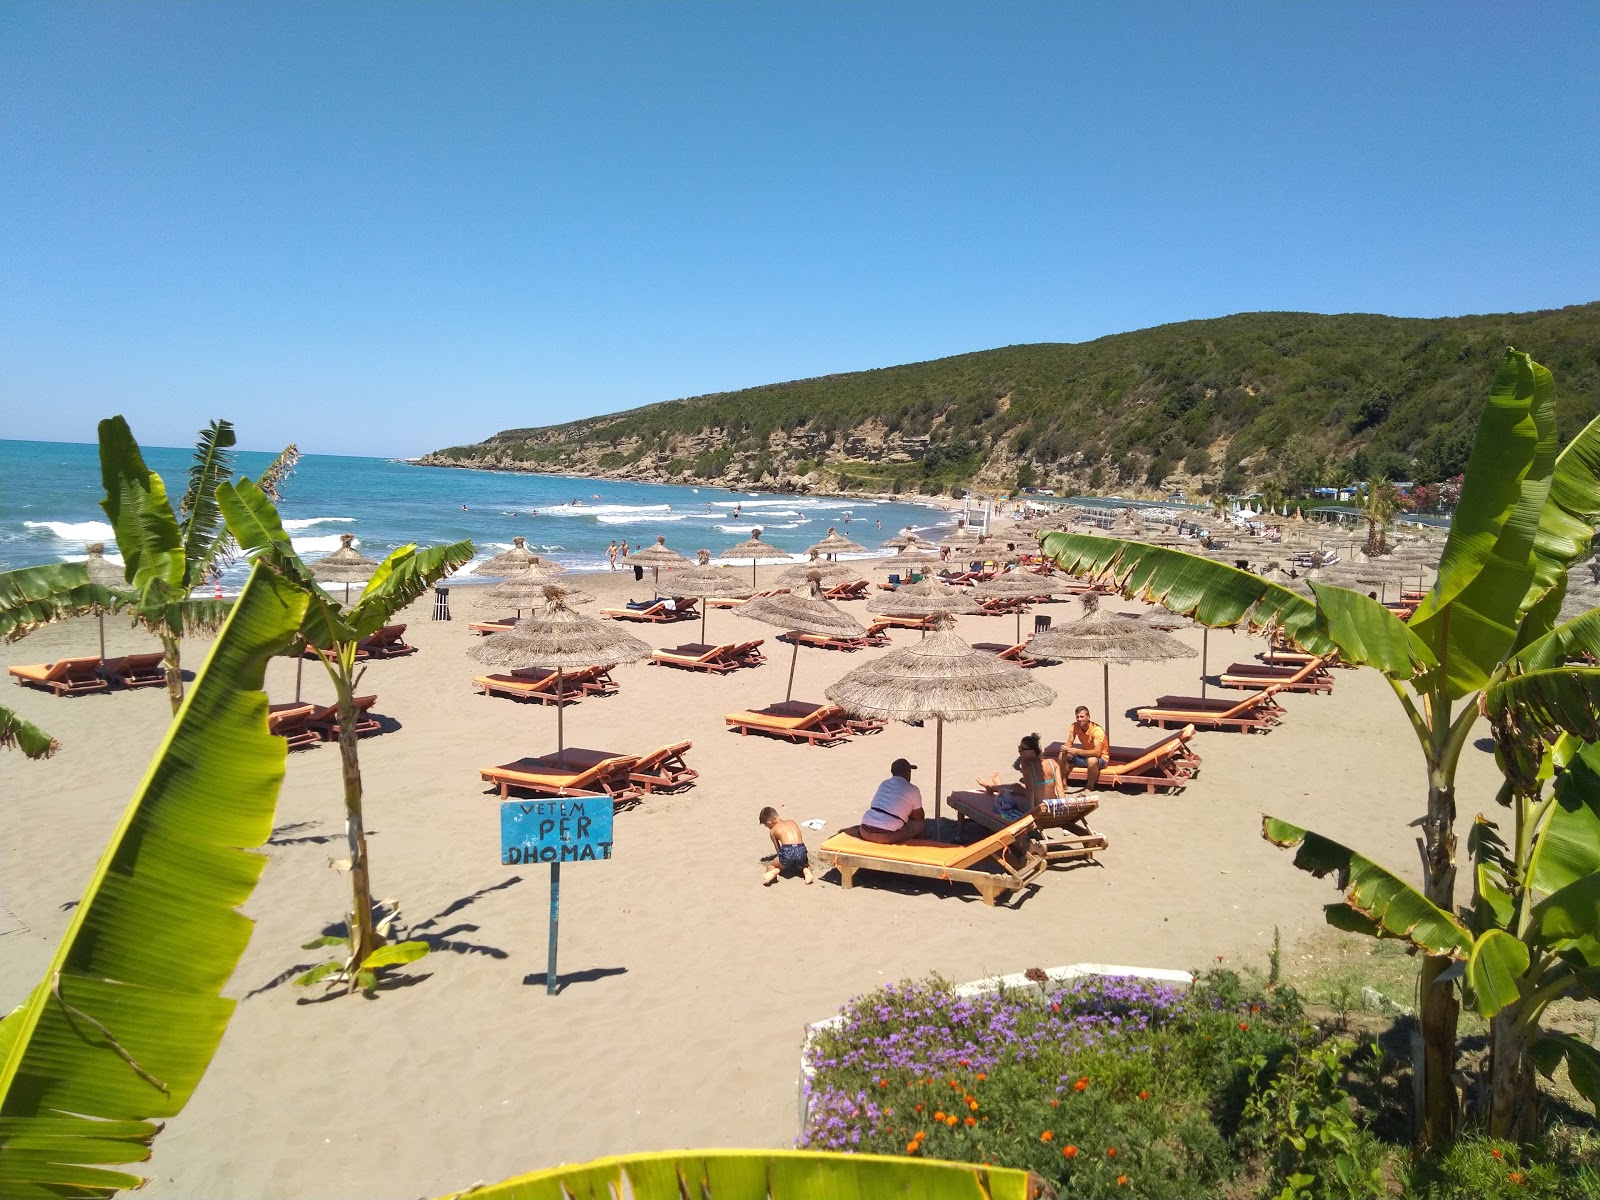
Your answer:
432;1150;1054;1200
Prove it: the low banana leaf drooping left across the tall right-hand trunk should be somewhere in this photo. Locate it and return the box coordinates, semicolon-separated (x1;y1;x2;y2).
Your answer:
1261;816;1472;958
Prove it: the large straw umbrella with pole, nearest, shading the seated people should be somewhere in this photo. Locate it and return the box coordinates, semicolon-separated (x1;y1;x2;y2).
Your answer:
826;629;1056;821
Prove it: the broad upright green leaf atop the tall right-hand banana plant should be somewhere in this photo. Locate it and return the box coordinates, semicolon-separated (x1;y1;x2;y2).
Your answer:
1408;350;1557;699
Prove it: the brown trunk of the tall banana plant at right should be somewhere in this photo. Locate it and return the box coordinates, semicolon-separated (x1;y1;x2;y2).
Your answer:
1413;779;1461;1147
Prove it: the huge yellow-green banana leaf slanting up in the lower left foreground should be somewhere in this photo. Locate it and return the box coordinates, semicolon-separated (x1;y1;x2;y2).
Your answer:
0;568;306;1198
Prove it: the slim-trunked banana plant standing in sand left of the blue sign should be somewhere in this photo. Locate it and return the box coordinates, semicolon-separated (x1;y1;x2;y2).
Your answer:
218;480;472;992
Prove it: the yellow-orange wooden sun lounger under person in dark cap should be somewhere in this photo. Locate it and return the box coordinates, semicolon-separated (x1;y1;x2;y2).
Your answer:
816;816;1048;906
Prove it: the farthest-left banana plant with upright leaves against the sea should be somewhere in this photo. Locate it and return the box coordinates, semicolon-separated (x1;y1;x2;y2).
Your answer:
99;416;298;712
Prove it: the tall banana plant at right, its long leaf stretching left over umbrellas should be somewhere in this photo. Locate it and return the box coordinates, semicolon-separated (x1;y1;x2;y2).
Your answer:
1042;350;1600;1146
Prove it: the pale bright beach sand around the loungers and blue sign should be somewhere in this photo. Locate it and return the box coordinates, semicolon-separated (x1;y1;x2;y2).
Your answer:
0;550;1494;1197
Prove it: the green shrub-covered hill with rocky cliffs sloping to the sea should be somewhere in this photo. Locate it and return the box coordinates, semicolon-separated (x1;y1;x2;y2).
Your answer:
421;310;1600;496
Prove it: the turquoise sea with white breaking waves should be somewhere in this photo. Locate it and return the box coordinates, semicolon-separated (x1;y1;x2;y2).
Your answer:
0;442;954;582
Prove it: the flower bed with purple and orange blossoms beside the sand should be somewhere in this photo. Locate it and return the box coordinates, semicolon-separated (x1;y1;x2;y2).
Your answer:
800;973;1299;1198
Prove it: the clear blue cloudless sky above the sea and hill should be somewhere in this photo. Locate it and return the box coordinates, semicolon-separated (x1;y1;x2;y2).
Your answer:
0;0;1600;454
